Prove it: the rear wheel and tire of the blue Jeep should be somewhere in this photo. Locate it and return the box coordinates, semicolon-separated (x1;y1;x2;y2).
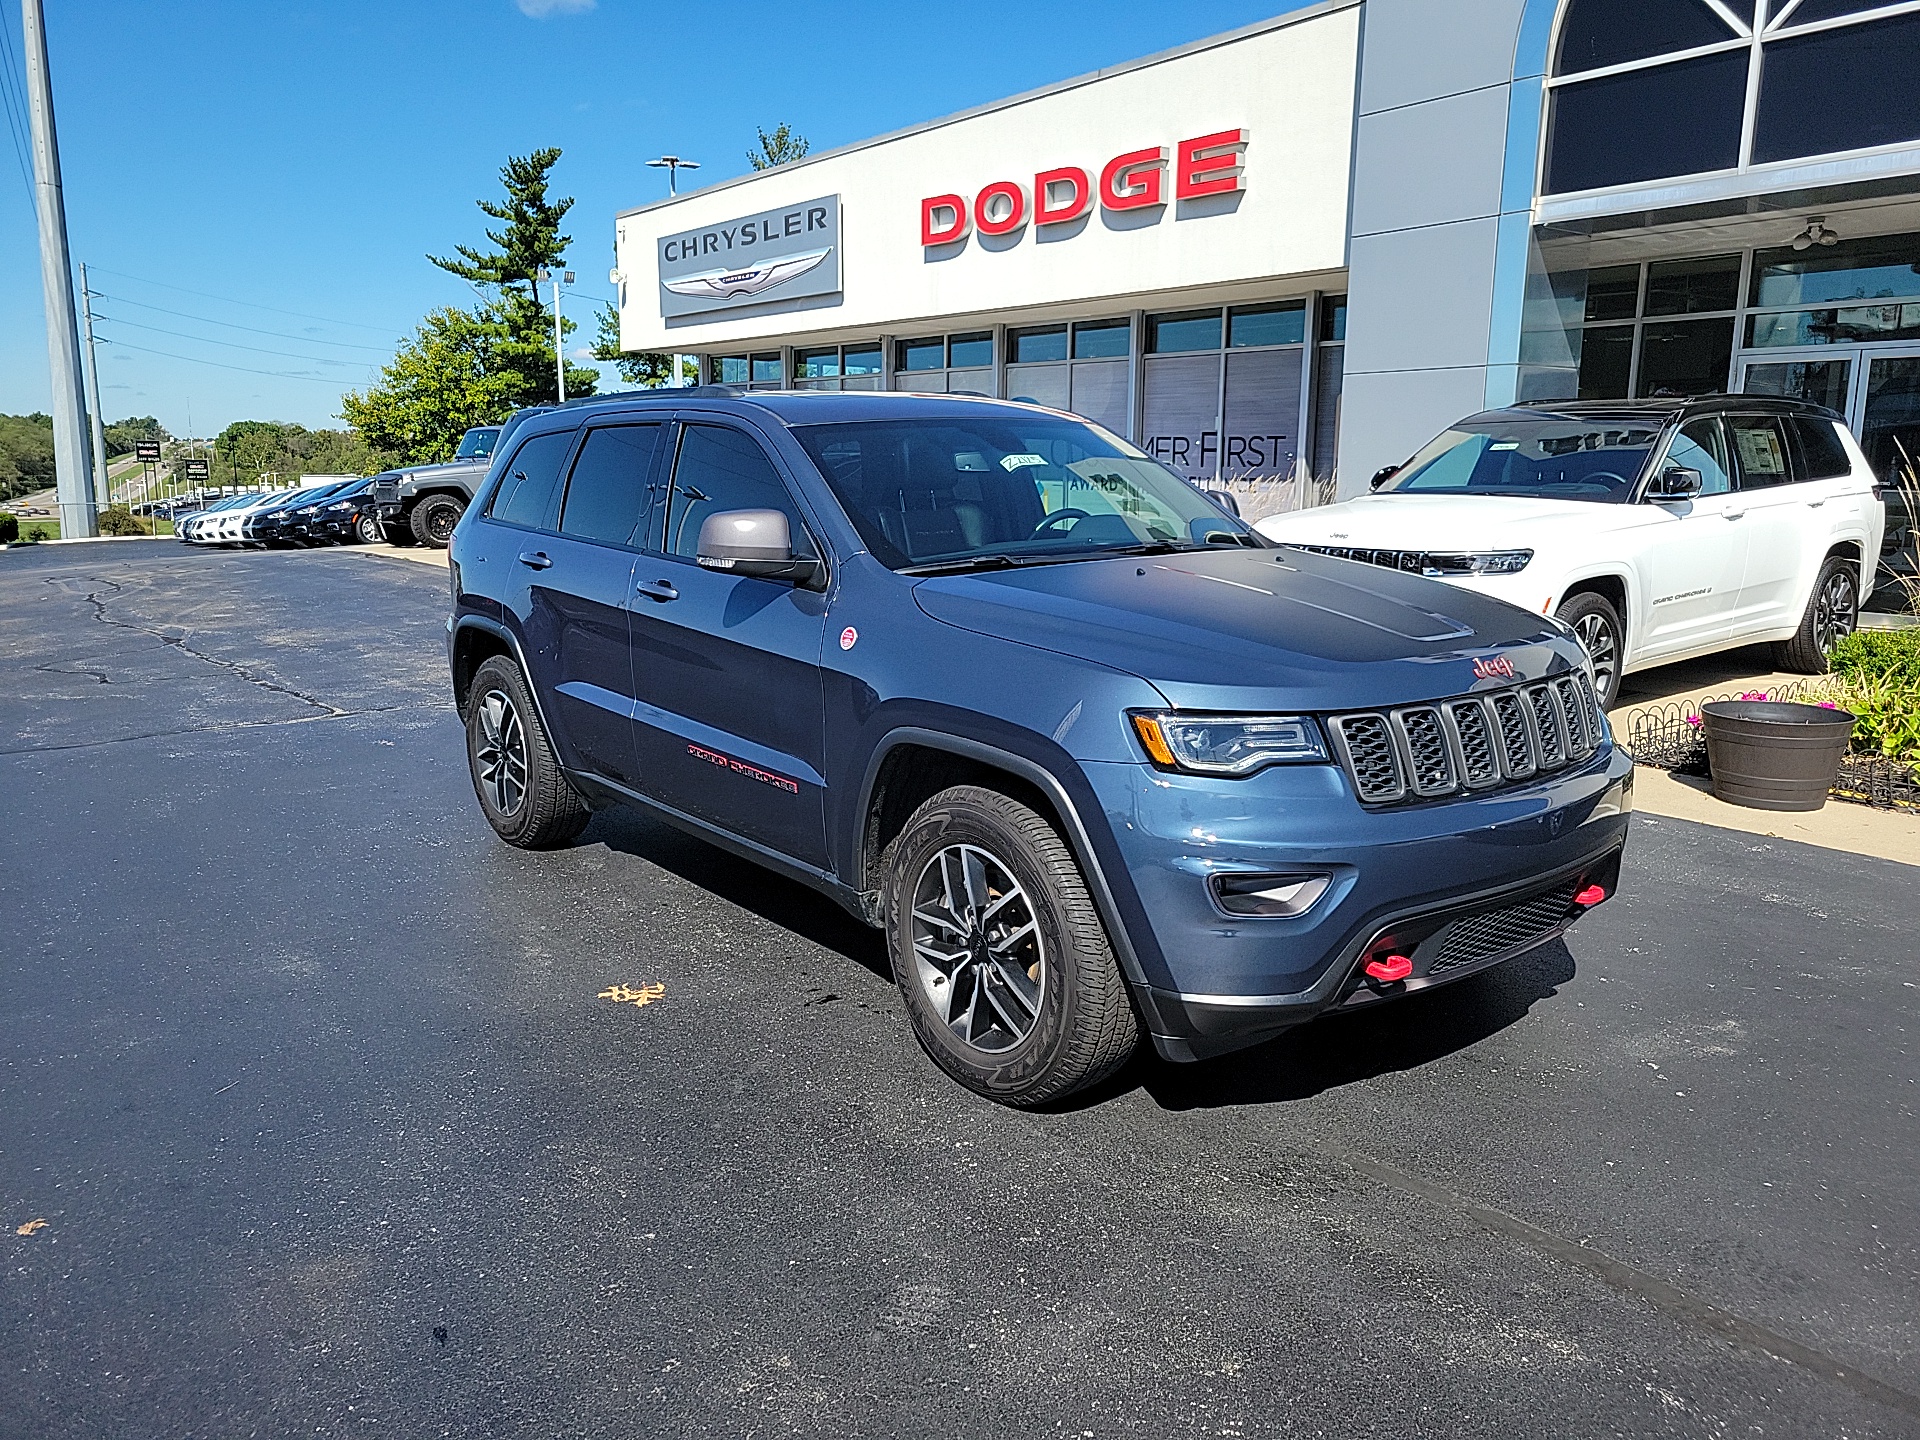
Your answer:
467;655;591;851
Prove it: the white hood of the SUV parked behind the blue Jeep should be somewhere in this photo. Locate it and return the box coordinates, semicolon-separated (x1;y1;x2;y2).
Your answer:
1254;493;1647;551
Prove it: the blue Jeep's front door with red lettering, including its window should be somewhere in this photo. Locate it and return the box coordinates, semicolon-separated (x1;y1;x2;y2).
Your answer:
632;417;828;870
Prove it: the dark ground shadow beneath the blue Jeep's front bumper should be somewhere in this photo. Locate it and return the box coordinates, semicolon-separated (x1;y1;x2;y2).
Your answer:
1098;941;1574;1110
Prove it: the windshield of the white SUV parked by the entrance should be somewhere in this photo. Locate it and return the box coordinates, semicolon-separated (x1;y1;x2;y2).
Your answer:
1382;415;1661;501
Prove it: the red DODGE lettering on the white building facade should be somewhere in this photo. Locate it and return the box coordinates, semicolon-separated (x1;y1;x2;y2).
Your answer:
920;131;1246;250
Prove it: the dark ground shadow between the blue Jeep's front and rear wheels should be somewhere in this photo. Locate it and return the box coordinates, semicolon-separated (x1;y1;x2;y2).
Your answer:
582;804;893;985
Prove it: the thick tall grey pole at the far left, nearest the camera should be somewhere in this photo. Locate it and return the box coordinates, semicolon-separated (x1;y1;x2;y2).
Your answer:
19;0;100;538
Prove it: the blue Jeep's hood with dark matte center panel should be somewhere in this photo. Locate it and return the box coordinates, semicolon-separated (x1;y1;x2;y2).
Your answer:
914;549;1582;710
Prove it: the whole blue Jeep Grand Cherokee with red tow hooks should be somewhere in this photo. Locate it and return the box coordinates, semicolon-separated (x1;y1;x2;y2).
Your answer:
449;388;1632;1106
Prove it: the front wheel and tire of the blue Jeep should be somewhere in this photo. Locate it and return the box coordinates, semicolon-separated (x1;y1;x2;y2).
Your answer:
881;785;1140;1108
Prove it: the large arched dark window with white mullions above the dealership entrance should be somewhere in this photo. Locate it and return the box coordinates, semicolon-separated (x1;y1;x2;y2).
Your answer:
1544;0;1920;194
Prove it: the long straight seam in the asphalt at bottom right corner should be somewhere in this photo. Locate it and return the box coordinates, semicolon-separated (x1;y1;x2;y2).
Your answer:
1311;1140;1920;1417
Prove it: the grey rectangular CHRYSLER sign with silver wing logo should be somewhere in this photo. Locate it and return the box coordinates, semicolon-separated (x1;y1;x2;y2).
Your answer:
659;196;841;317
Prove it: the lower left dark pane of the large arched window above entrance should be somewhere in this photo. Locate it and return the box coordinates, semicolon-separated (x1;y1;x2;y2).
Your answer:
1546;50;1747;194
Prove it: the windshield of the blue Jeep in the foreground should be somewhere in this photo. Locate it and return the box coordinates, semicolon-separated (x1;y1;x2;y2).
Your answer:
793;409;1260;570
